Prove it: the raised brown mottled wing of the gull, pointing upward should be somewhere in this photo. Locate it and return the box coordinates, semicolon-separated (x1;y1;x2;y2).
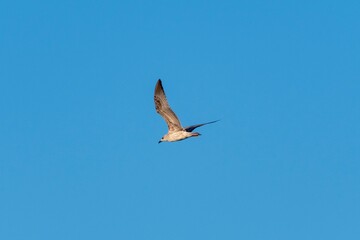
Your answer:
154;79;182;132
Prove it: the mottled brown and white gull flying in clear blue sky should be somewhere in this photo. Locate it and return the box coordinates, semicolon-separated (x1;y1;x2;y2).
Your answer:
154;79;219;143
